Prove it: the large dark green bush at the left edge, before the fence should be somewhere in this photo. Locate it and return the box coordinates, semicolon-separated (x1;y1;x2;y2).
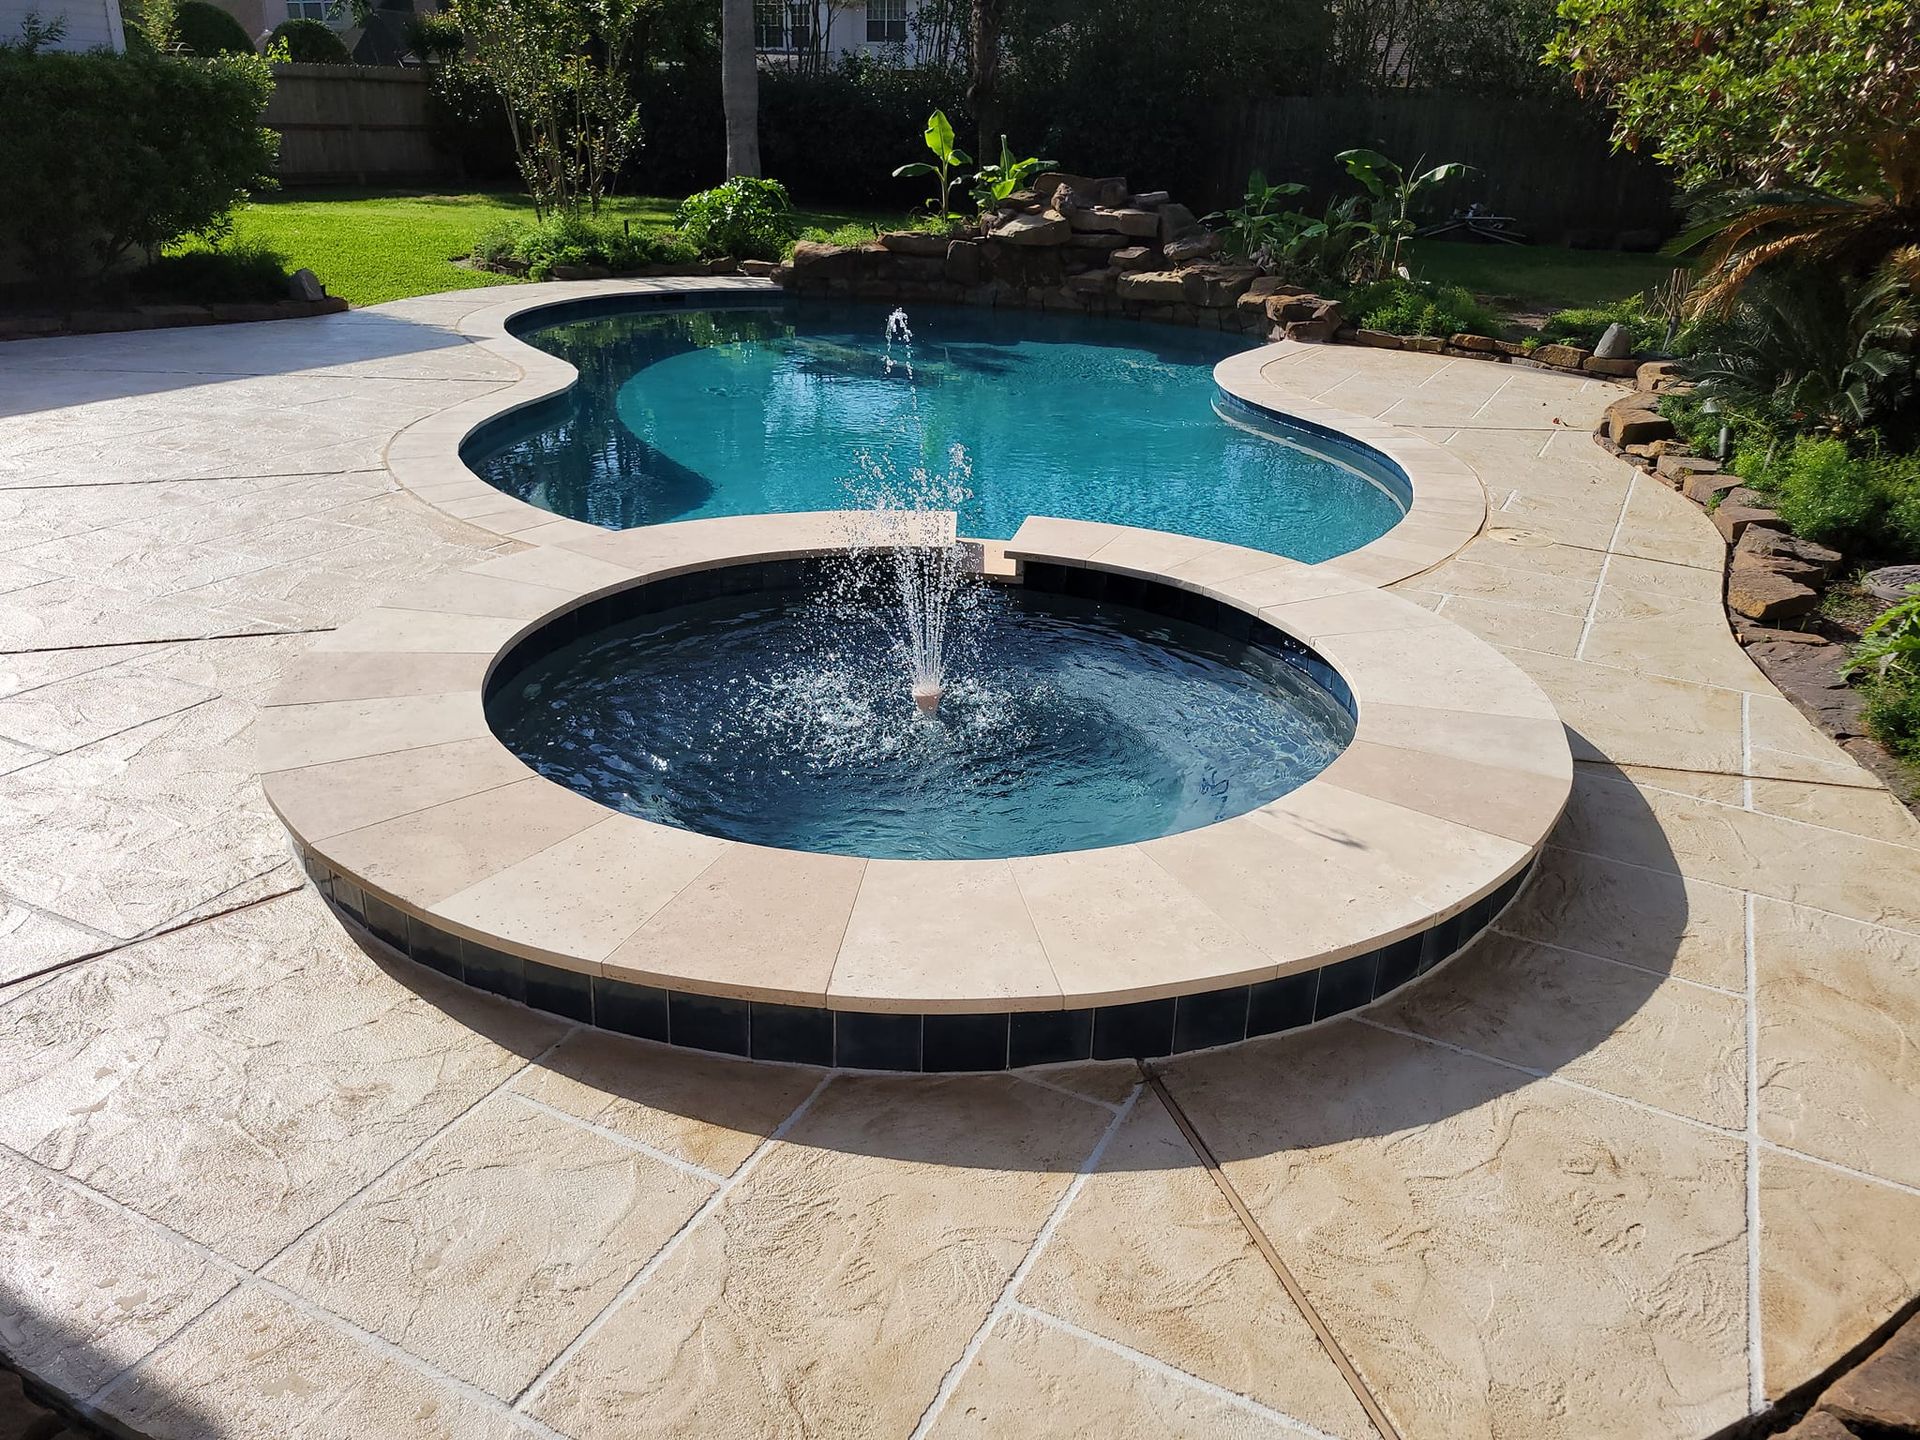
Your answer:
0;52;278;284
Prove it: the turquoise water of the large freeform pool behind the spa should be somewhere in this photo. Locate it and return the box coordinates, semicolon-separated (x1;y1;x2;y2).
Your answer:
463;300;1405;561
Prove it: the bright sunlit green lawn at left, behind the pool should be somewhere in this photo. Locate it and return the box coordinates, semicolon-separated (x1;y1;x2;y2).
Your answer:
214;190;897;305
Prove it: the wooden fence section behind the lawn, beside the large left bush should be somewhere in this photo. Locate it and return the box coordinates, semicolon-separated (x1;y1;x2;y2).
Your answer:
261;65;451;184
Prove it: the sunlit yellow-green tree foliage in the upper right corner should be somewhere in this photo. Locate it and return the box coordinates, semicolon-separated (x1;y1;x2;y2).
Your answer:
1546;0;1920;194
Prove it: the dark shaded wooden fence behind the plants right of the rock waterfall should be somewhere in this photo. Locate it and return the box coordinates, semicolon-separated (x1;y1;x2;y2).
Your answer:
1210;94;1674;250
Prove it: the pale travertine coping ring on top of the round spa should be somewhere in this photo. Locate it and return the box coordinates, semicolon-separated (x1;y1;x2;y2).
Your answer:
259;513;1572;1014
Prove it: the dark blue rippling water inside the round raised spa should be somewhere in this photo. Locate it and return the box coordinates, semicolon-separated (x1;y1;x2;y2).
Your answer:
486;557;1354;860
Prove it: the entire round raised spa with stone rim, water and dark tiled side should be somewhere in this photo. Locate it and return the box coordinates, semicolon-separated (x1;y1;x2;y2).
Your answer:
261;515;1571;1071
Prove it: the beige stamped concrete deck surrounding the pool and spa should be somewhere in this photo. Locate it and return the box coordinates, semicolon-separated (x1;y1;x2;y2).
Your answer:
0;284;1920;1440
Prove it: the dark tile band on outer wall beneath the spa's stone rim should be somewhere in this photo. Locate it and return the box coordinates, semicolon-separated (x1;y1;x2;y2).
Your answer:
301;854;1536;1073
